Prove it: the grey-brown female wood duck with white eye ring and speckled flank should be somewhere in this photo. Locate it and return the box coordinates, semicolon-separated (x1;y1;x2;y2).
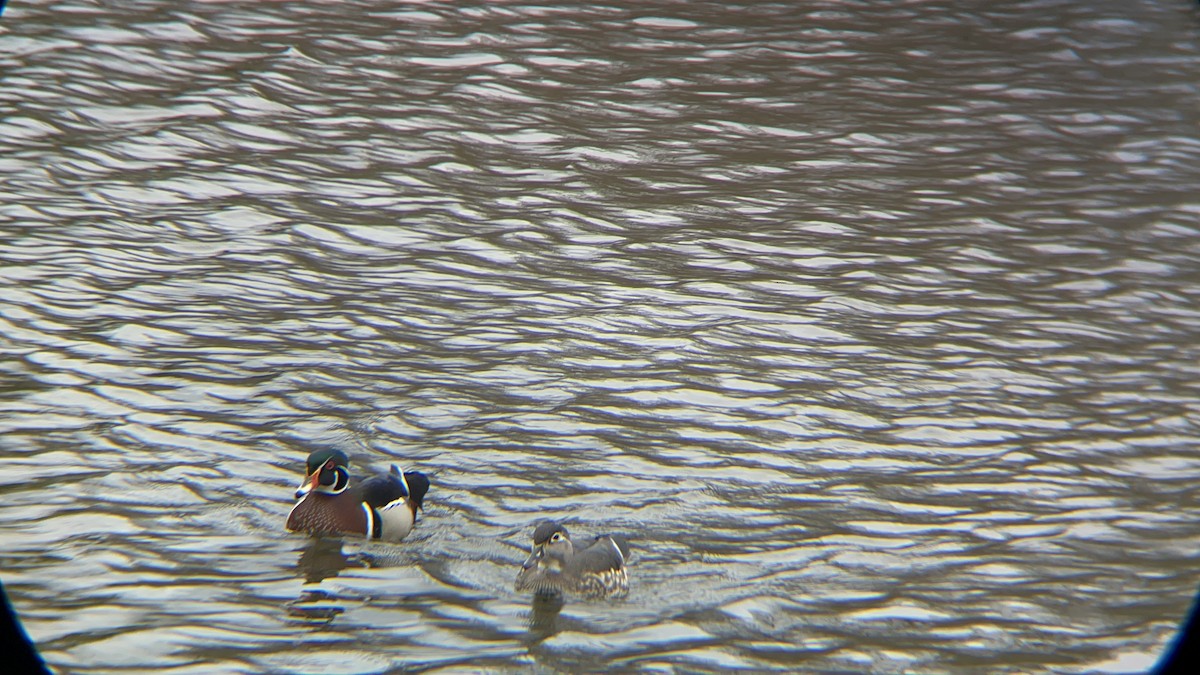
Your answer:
516;521;629;599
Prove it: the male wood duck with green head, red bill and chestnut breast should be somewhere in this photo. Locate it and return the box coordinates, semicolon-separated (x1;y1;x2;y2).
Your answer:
287;450;430;542
